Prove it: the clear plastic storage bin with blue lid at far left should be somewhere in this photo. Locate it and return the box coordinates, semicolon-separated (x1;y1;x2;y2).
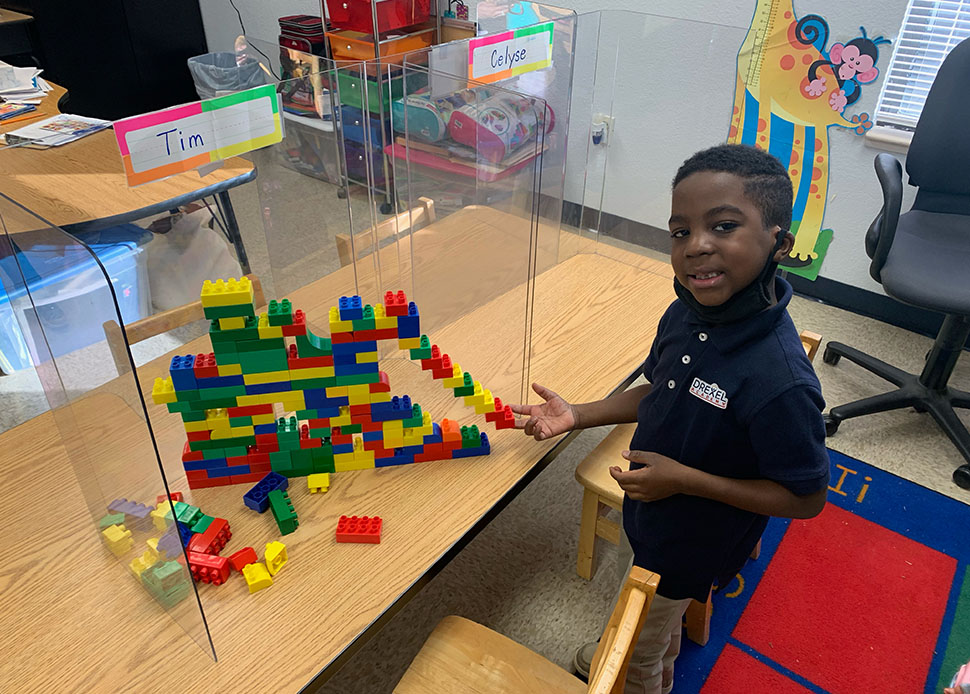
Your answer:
0;227;152;373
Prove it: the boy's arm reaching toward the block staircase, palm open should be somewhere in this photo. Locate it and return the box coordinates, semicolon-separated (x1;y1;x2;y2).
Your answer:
511;383;651;441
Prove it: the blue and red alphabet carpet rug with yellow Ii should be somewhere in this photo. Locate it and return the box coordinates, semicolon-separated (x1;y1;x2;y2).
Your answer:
674;451;970;694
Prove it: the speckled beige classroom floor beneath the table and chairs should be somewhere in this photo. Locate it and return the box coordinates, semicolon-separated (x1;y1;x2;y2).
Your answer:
0;174;970;694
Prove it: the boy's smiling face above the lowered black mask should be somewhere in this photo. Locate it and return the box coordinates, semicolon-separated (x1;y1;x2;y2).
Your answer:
669;171;792;306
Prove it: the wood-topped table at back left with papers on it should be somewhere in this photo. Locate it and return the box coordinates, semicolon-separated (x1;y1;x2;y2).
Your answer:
0;85;256;273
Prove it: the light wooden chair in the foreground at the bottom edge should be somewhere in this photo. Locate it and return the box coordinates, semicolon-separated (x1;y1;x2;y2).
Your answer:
394;566;660;694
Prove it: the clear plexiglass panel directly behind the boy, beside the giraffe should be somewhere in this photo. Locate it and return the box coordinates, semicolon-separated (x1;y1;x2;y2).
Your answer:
564;11;745;268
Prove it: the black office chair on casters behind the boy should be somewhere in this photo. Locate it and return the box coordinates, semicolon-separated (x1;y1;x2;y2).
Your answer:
822;39;970;489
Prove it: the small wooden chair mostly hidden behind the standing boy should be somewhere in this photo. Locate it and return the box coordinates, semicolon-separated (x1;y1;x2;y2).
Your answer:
576;330;822;646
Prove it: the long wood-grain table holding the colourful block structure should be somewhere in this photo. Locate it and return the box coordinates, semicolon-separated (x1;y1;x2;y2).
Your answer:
0;208;673;694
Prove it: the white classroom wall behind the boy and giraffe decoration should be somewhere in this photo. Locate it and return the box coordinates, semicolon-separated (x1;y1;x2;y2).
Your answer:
200;0;912;292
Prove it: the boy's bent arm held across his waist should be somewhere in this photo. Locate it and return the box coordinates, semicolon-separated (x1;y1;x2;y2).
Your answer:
610;451;827;518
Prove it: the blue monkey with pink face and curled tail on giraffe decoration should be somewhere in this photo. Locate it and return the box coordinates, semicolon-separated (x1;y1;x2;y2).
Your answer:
795;14;889;113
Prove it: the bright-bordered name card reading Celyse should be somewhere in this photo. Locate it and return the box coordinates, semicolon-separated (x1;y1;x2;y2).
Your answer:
468;22;553;82
